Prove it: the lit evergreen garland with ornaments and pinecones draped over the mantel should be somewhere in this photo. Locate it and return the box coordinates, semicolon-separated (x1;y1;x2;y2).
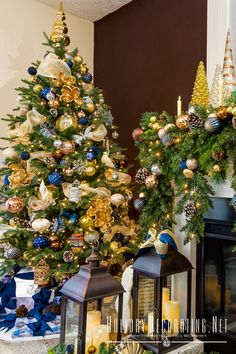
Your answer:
133;103;236;243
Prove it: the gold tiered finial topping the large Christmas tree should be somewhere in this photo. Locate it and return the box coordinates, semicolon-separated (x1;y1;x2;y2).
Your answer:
50;1;70;46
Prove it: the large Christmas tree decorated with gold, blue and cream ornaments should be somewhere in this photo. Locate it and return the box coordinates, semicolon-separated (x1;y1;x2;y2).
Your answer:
1;2;135;285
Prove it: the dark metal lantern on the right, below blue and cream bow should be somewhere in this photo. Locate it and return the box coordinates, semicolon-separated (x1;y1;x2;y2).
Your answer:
132;246;192;353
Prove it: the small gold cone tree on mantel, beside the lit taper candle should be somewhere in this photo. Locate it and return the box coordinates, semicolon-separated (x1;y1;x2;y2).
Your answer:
190;61;209;106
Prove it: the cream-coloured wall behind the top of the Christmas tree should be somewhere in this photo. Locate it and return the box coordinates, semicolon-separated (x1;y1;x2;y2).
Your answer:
0;0;94;145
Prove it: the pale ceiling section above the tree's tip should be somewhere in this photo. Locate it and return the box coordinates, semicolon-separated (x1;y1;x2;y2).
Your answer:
36;0;132;22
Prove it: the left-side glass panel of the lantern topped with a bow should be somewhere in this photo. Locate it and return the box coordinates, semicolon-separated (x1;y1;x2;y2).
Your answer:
137;275;154;335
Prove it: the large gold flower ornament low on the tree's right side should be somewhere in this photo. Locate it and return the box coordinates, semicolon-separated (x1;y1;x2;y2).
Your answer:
86;198;112;232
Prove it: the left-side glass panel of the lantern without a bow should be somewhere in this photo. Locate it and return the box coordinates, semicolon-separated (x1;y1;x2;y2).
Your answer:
65;299;80;344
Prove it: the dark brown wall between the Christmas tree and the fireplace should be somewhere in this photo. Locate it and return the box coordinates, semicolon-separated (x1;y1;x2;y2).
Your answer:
94;0;207;163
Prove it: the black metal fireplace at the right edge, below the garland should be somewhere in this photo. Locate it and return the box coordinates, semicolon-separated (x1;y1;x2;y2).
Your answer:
196;198;236;354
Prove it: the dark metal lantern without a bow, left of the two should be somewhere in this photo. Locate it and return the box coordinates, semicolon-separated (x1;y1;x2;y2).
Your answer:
60;250;124;354
